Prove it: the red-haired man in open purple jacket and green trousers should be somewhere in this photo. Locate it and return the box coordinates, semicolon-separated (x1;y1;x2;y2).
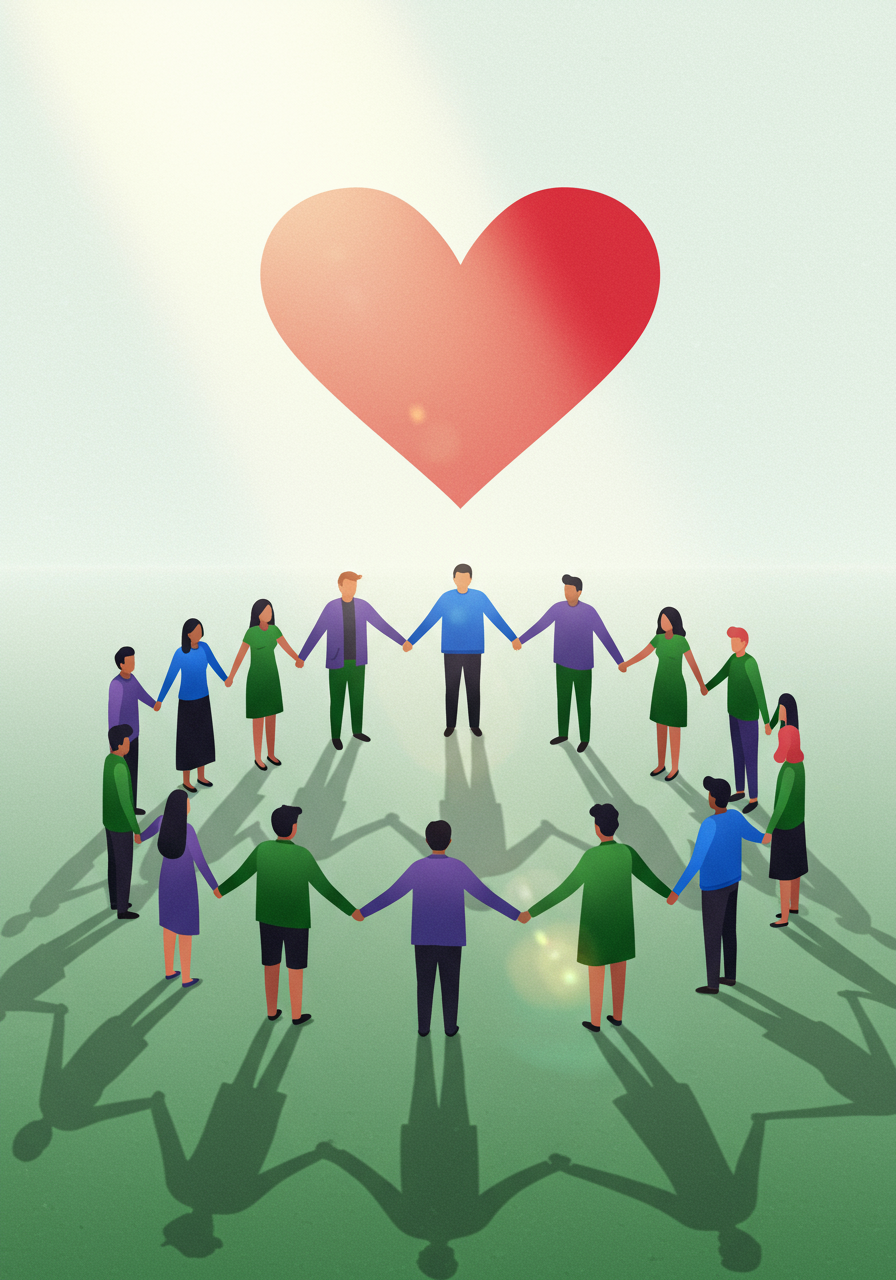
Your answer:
296;573;412;751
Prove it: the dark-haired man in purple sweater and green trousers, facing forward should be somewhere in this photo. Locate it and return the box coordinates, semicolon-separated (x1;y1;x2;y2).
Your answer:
513;573;622;751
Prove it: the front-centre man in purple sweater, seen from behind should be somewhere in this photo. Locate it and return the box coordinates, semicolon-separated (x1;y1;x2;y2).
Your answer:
353;820;521;1036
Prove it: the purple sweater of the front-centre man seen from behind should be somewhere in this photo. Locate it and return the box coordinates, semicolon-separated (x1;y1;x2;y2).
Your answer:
361;854;520;947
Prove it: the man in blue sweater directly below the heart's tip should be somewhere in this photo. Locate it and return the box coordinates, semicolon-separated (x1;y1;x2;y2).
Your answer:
408;564;520;737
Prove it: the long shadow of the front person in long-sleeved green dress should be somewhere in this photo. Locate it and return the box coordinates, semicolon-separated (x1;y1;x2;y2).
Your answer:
564;1027;764;1271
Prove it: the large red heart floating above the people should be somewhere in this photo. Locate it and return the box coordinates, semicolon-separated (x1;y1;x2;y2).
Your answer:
261;187;659;507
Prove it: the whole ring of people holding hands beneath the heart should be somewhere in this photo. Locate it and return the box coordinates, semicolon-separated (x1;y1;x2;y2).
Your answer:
102;564;808;1036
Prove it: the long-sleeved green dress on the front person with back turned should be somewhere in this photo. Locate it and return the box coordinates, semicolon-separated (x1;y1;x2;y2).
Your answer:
529;840;672;965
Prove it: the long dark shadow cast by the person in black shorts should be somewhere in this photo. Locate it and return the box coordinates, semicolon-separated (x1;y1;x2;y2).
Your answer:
151;1021;321;1258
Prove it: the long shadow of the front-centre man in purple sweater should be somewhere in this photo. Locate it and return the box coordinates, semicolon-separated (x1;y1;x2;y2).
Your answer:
317;1036;559;1277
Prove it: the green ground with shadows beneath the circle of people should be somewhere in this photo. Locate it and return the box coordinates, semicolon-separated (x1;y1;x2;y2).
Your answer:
0;571;896;1280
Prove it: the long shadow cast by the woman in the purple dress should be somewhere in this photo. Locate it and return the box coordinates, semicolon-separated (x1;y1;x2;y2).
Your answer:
13;978;188;1160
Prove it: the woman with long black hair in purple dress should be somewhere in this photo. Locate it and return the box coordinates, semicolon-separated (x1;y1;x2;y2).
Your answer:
141;791;221;987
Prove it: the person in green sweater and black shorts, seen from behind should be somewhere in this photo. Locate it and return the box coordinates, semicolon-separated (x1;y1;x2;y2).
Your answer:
218;804;355;1027
